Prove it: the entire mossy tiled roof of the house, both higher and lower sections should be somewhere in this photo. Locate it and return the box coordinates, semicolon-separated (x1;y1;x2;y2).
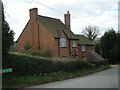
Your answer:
38;15;93;45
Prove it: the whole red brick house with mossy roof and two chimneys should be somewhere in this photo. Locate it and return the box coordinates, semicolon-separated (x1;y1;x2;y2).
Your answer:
17;8;94;60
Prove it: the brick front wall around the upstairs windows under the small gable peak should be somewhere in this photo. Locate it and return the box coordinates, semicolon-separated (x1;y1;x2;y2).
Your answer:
55;32;78;58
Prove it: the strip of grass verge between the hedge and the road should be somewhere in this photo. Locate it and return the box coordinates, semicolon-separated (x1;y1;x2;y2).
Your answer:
2;65;111;88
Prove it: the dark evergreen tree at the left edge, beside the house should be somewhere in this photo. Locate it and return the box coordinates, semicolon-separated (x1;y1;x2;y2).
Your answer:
2;4;14;58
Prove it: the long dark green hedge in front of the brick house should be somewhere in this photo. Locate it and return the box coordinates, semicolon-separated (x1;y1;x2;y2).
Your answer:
3;54;94;76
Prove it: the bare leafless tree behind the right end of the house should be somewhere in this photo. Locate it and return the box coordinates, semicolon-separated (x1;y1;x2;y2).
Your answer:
82;25;100;41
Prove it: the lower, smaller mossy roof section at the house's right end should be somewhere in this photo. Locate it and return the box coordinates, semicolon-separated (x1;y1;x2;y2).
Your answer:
76;35;93;45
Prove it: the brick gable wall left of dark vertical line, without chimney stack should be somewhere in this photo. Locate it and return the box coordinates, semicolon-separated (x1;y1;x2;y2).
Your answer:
17;20;38;52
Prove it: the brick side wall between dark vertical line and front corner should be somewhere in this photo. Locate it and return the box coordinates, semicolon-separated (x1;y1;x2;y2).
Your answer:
38;21;55;56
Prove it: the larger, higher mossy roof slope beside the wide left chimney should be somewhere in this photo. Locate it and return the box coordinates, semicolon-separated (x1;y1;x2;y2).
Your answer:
38;15;77;39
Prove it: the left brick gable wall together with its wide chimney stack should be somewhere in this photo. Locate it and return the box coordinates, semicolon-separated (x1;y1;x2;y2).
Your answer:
17;8;38;52
